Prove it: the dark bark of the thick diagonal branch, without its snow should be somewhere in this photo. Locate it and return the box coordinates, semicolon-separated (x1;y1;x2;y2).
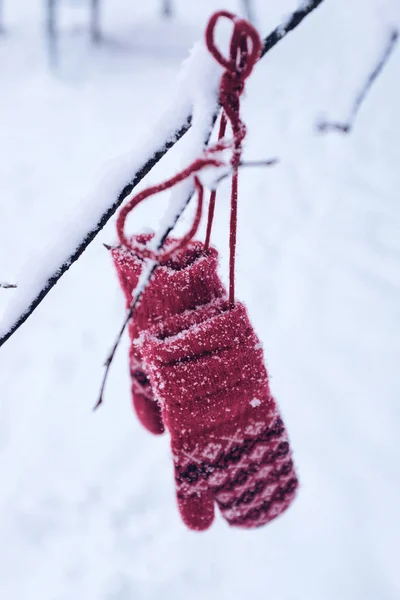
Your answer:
0;0;324;347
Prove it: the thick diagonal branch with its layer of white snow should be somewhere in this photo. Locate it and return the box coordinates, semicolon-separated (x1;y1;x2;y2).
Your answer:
0;0;323;347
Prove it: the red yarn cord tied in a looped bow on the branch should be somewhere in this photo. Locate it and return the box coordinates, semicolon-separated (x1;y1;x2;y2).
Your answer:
117;11;262;306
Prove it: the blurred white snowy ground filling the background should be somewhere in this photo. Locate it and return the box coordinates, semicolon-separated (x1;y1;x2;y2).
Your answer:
0;0;400;600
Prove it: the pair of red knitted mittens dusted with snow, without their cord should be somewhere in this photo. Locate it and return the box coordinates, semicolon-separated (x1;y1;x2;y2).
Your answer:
113;236;298;530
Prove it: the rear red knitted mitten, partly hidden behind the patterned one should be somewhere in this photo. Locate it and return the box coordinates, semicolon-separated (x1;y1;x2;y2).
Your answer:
111;235;225;434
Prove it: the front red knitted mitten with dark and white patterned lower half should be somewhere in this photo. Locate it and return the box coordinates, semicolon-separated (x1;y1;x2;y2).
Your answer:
137;300;298;530
